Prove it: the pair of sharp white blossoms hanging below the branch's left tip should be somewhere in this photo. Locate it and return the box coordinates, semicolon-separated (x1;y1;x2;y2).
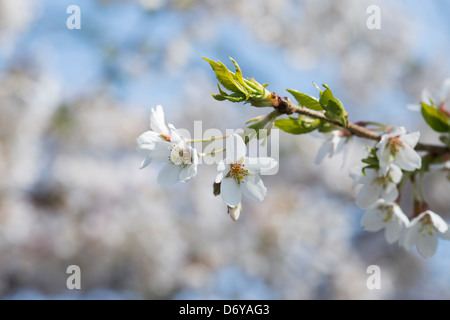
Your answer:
136;106;277;221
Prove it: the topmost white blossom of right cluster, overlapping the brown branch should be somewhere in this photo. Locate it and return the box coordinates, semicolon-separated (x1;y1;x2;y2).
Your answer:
377;127;422;176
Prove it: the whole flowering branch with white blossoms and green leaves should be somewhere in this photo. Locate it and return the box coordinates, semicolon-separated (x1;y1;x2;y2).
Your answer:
136;66;450;257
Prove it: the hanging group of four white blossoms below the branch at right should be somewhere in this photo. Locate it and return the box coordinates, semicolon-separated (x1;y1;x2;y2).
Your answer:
350;127;450;257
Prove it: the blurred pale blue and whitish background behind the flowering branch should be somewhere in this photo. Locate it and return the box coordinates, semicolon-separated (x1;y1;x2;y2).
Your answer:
0;0;450;299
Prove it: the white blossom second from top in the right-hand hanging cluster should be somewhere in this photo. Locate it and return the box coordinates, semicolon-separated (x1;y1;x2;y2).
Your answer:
350;164;402;209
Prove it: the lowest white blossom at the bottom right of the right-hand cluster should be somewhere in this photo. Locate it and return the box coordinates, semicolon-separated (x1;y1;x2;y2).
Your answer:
402;210;450;258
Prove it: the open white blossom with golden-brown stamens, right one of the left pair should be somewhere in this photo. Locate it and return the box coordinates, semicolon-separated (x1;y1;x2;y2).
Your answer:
215;134;277;208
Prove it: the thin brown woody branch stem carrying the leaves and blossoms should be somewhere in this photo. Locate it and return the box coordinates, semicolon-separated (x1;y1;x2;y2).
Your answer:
273;96;450;155
